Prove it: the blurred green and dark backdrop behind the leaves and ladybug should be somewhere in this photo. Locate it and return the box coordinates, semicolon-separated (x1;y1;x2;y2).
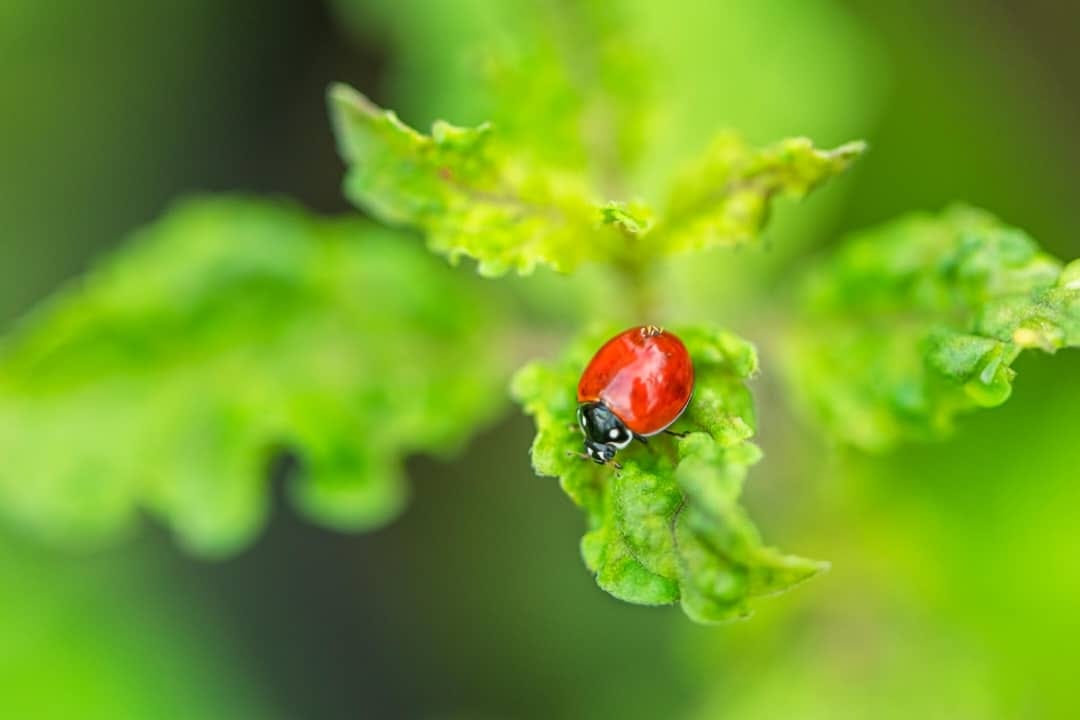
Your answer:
0;0;1080;718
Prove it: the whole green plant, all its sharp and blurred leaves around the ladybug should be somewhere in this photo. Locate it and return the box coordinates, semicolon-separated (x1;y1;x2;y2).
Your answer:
8;0;1045;634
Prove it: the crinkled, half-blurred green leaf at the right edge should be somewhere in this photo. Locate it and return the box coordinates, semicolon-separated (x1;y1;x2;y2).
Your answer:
788;207;1080;450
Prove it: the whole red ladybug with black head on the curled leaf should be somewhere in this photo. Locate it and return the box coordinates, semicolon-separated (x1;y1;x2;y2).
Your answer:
578;325;693;467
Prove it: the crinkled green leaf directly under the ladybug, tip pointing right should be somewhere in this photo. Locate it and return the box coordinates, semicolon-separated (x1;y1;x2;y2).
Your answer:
513;328;824;623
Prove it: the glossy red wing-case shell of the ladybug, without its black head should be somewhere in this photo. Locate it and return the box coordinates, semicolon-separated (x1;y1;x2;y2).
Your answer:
578;326;693;437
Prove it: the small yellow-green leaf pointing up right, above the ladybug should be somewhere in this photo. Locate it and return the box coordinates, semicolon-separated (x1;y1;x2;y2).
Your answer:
653;133;866;254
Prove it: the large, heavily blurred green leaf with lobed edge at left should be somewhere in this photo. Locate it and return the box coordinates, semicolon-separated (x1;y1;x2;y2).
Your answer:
0;199;504;554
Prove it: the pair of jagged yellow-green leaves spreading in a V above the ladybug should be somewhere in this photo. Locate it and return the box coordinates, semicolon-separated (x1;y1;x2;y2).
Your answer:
330;85;864;275
